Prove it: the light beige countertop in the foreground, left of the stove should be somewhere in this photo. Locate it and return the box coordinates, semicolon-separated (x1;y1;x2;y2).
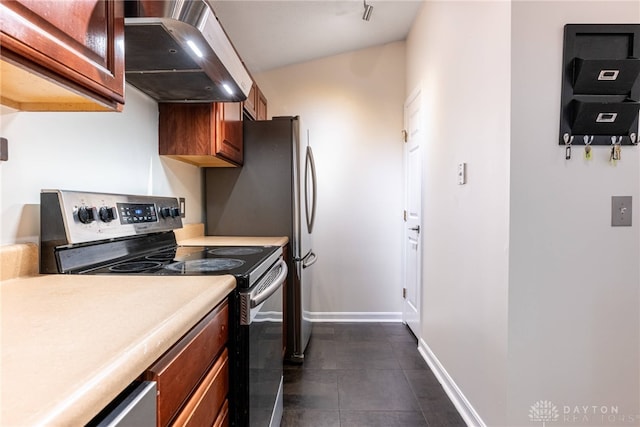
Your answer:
0;275;235;426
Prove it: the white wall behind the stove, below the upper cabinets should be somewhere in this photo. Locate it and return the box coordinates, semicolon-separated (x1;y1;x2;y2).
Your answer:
0;86;203;244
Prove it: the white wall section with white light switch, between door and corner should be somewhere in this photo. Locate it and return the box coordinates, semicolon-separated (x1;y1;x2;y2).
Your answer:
405;1;510;425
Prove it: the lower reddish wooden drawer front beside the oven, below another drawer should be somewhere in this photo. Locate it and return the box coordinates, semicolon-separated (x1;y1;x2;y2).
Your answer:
173;350;229;427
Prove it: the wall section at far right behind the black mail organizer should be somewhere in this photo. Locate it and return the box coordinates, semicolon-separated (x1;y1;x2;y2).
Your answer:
508;0;640;425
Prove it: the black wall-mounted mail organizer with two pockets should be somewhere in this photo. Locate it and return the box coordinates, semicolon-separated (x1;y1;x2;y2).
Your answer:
559;24;640;152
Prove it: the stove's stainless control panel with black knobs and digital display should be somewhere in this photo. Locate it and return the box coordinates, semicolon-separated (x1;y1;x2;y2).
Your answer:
40;190;182;244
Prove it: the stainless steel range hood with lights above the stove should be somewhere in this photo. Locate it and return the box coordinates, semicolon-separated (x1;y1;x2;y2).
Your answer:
124;0;252;102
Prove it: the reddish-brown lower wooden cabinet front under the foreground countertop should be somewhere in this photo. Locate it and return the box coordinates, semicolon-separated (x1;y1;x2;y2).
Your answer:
143;300;229;427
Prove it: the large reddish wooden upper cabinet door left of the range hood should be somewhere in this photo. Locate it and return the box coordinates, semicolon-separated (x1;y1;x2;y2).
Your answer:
0;0;124;110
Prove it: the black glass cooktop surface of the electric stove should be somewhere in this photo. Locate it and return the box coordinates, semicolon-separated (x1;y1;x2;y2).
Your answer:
82;246;280;290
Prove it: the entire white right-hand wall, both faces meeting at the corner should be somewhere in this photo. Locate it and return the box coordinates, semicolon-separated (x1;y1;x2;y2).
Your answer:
406;0;640;426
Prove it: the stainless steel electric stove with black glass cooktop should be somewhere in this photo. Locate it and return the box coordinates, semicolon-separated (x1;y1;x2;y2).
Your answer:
40;190;287;426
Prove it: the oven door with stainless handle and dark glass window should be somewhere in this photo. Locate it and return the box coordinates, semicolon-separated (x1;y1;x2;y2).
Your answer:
238;260;287;427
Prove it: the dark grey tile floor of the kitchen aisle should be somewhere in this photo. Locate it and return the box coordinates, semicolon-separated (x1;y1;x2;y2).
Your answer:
281;323;465;427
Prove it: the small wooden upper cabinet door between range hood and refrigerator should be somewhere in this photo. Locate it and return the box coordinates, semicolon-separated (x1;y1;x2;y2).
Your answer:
215;102;244;165
